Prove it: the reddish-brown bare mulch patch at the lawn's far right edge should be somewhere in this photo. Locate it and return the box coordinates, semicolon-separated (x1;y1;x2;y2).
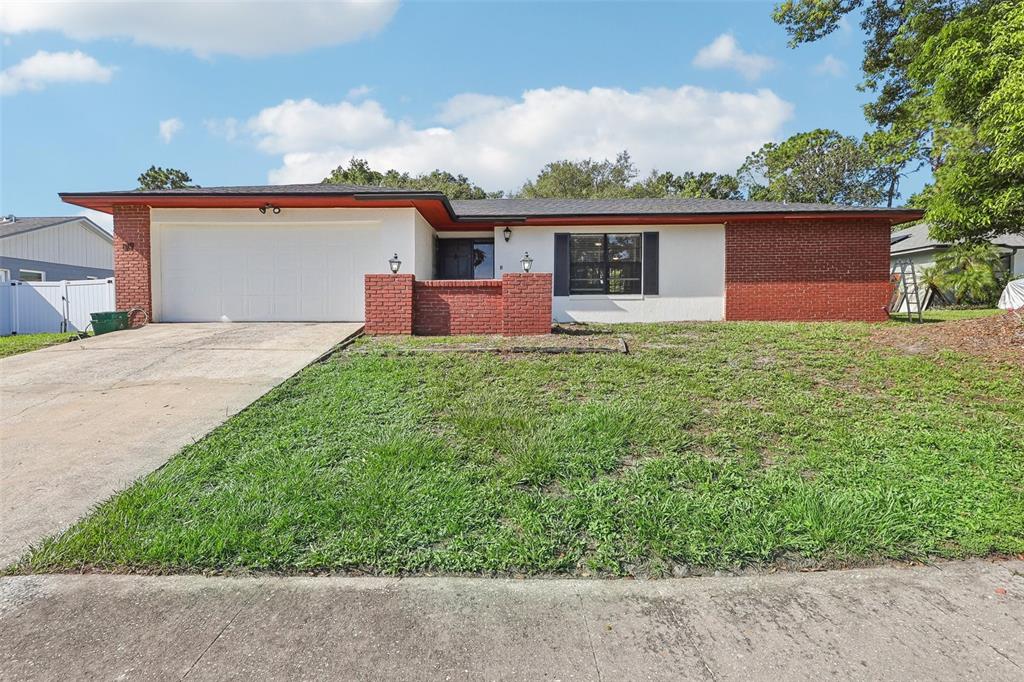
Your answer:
871;312;1024;364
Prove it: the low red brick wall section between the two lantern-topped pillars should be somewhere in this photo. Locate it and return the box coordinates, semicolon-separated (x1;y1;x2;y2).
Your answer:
413;280;502;336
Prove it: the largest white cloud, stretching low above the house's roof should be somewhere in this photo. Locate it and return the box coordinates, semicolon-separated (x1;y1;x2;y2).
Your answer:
237;86;793;189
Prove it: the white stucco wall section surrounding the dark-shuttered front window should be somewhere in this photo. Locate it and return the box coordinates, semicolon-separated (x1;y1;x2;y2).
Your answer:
495;224;725;323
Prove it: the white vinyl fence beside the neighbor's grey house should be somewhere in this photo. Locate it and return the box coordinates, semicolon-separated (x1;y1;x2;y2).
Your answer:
0;278;114;336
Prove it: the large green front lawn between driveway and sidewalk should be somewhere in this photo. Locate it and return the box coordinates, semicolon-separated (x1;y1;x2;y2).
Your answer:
16;323;1024;576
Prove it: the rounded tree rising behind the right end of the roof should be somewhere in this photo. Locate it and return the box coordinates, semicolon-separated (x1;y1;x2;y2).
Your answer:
737;128;886;201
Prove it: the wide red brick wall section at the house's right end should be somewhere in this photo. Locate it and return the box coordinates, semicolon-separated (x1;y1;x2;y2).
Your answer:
725;219;890;322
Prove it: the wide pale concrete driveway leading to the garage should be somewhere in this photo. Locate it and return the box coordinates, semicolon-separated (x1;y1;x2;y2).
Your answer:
0;323;361;566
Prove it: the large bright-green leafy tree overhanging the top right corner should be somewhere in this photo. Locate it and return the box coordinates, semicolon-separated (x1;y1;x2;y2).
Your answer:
774;0;1024;241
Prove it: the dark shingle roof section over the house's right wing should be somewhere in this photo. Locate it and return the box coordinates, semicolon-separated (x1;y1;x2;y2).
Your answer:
452;199;901;217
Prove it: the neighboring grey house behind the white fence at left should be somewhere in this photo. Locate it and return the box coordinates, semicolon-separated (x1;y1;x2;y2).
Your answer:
0;215;114;282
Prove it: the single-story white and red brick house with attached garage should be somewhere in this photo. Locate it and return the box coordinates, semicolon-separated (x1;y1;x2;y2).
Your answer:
60;184;922;333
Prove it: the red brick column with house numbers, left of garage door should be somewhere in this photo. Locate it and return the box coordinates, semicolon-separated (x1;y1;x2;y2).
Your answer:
114;204;153;325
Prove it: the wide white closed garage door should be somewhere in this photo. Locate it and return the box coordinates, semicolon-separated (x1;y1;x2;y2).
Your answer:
158;225;379;322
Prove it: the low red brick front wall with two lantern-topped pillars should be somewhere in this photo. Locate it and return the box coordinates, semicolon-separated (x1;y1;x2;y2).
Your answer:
365;272;552;336
